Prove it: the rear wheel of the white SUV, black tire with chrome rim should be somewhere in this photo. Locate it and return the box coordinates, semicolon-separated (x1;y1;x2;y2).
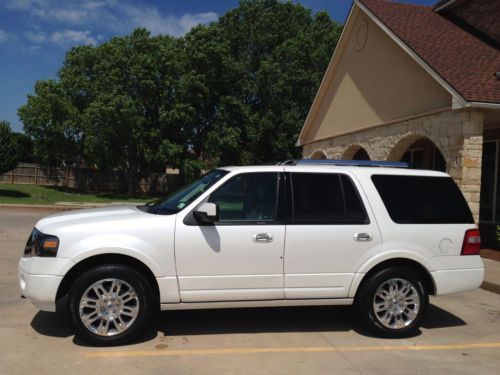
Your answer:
356;267;429;337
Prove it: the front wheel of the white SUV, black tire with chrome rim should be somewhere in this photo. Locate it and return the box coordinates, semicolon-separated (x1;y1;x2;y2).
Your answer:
68;265;153;345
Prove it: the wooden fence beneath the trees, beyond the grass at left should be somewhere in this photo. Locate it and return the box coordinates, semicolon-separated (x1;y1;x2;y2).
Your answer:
0;163;180;193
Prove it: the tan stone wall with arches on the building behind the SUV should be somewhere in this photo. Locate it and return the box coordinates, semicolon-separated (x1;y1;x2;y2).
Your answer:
303;110;483;222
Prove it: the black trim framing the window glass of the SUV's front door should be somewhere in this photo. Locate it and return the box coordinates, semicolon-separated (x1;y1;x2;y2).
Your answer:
183;171;285;227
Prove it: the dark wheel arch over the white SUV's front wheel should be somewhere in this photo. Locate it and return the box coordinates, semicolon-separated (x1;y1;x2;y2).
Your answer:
56;253;160;303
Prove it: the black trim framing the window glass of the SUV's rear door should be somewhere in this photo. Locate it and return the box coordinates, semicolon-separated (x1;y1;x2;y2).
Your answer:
286;171;371;225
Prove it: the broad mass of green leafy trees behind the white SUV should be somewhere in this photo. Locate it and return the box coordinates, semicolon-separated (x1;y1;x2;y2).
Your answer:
19;0;341;194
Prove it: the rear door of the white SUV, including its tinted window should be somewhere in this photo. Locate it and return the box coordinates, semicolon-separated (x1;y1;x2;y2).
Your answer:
284;173;382;299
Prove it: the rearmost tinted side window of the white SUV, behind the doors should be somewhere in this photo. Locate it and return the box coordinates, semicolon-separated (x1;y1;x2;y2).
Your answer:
372;175;474;224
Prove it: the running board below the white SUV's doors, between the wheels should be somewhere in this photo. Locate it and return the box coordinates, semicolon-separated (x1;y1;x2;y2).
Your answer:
160;298;353;310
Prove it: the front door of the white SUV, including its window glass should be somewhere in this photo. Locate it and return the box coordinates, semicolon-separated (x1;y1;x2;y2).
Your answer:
175;173;285;302
